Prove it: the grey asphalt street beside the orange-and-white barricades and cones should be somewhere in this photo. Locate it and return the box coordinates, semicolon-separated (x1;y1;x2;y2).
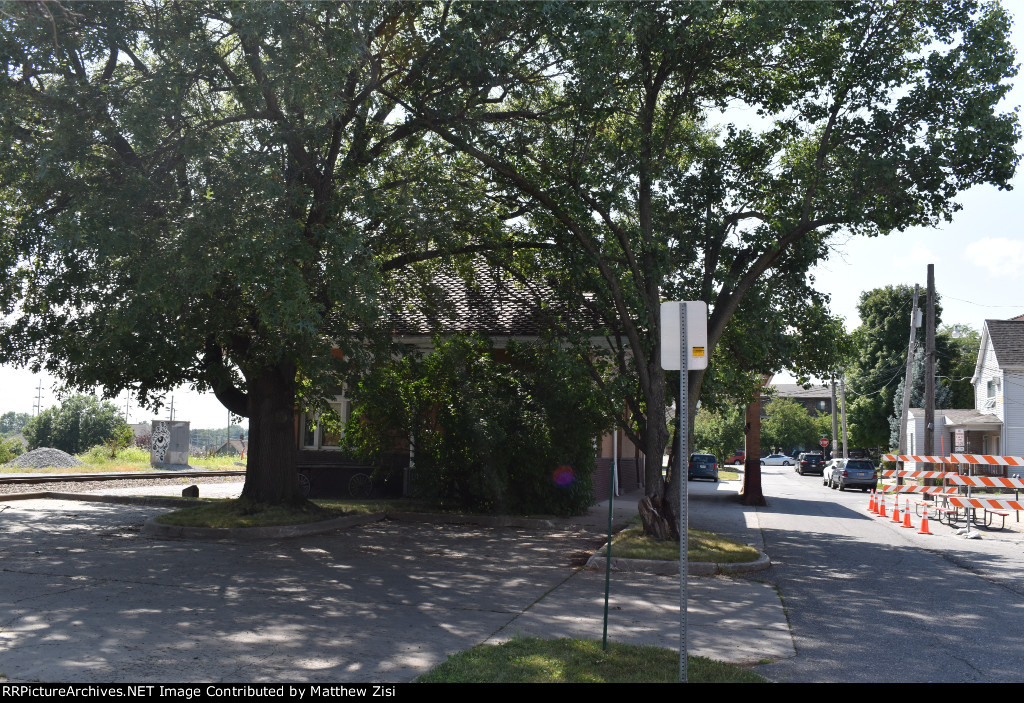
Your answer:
751;467;1024;683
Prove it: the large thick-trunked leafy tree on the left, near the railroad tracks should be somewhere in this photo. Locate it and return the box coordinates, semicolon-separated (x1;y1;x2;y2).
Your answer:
0;0;552;502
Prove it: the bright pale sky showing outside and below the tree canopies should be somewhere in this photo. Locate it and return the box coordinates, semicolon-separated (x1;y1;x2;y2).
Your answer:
0;5;1024;428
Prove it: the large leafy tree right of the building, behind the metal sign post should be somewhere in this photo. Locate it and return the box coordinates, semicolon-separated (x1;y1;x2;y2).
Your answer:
406;1;1019;517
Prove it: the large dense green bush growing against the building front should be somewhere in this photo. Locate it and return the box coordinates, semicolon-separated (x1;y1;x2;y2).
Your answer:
345;337;609;515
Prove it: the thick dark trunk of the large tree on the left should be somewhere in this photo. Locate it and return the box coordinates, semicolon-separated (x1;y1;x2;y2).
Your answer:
242;361;306;506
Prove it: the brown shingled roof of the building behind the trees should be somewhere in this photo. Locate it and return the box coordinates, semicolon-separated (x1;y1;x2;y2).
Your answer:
391;266;601;337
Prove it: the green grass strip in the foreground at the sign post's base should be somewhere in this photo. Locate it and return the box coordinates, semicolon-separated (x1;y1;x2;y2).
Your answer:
416;638;767;684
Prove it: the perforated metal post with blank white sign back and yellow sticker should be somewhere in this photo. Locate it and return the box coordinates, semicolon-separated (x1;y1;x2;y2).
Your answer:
662;301;708;684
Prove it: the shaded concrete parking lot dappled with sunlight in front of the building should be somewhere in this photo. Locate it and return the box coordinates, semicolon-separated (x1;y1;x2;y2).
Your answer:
0;499;792;683
